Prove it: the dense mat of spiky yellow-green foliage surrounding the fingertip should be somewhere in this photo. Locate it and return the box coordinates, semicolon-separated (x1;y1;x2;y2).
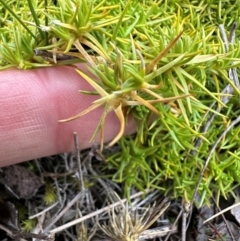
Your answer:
0;0;240;203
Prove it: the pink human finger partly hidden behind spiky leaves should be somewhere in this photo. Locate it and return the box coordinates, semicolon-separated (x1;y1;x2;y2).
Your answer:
0;65;134;166
